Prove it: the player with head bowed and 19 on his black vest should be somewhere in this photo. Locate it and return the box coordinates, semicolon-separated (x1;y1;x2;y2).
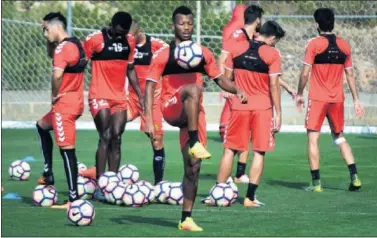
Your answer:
80;12;144;197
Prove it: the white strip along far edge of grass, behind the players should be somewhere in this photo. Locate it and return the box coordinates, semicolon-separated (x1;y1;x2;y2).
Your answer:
1;121;377;134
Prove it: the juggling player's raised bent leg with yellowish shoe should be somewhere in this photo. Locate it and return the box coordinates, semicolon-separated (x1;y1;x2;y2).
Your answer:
180;84;211;159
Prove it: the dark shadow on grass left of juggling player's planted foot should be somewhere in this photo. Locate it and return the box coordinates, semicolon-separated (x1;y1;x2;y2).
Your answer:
110;215;178;228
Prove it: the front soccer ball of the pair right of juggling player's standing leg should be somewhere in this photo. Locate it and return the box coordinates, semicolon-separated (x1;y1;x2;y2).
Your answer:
209;183;234;207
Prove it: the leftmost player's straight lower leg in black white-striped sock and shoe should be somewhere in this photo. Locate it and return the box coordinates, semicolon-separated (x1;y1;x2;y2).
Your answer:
51;145;79;209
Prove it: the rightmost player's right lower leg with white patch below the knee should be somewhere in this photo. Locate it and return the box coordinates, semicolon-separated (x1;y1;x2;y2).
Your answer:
332;132;361;191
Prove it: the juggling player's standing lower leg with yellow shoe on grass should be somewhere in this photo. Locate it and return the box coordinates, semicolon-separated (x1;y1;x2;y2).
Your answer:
179;144;203;231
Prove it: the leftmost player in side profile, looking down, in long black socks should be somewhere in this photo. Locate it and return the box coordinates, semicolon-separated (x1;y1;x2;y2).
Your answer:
37;12;87;209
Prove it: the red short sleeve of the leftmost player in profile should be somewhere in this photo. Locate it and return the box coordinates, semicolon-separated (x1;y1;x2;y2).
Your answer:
53;41;80;70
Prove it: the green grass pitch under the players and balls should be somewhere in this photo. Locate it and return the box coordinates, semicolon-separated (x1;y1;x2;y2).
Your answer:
1;130;377;237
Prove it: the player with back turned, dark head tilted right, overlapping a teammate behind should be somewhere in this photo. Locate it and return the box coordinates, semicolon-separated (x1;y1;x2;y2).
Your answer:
217;21;285;207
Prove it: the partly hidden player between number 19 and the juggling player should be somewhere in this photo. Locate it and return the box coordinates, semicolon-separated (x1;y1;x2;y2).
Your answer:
127;20;167;184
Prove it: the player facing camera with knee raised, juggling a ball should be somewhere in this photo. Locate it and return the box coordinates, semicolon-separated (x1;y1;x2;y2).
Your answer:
145;6;246;231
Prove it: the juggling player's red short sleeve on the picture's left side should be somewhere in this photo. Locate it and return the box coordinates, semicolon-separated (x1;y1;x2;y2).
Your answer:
146;47;169;83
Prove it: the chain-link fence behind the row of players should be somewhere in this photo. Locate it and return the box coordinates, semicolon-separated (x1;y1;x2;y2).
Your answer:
2;1;377;127
